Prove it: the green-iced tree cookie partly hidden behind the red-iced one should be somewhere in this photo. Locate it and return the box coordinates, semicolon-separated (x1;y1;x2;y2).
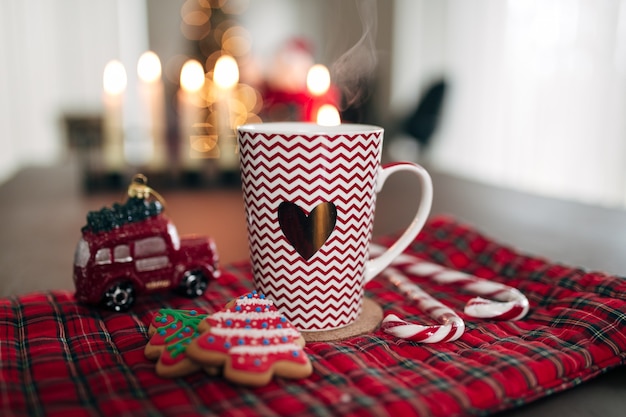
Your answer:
144;308;207;378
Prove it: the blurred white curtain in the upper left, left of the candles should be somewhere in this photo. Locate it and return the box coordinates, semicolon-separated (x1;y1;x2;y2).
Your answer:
0;0;147;182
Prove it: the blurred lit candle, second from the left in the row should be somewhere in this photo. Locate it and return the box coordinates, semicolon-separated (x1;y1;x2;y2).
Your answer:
137;51;167;170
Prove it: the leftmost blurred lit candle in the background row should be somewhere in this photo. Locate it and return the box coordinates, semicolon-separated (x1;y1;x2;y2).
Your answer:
102;60;128;174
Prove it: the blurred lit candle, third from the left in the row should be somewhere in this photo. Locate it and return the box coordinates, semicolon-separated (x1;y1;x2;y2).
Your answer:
178;59;204;171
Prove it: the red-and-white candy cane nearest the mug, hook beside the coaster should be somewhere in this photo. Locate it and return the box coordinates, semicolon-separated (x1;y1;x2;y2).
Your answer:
381;268;465;343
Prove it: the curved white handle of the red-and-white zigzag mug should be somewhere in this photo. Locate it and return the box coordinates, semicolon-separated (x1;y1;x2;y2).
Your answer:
363;162;433;284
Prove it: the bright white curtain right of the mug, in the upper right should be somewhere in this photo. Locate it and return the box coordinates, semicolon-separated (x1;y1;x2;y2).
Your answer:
430;0;626;207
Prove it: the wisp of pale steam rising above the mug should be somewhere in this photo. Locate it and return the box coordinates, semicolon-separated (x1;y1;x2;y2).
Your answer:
331;0;378;107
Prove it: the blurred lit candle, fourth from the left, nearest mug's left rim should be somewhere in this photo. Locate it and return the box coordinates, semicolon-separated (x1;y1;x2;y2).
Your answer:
213;55;239;171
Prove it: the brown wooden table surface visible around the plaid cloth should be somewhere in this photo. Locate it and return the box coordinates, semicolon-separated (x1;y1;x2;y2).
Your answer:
0;164;626;417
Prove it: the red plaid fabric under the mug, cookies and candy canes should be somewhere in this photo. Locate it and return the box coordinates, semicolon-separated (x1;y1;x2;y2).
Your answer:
0;218;626;417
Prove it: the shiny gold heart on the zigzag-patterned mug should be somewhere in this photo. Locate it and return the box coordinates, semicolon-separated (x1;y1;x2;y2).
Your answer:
278;201;337;260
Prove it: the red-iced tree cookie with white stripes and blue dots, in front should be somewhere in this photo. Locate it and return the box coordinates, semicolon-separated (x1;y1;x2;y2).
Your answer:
186;291;312;386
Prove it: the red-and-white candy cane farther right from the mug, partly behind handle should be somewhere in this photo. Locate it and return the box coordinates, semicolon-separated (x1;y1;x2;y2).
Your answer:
373;245;529;320
